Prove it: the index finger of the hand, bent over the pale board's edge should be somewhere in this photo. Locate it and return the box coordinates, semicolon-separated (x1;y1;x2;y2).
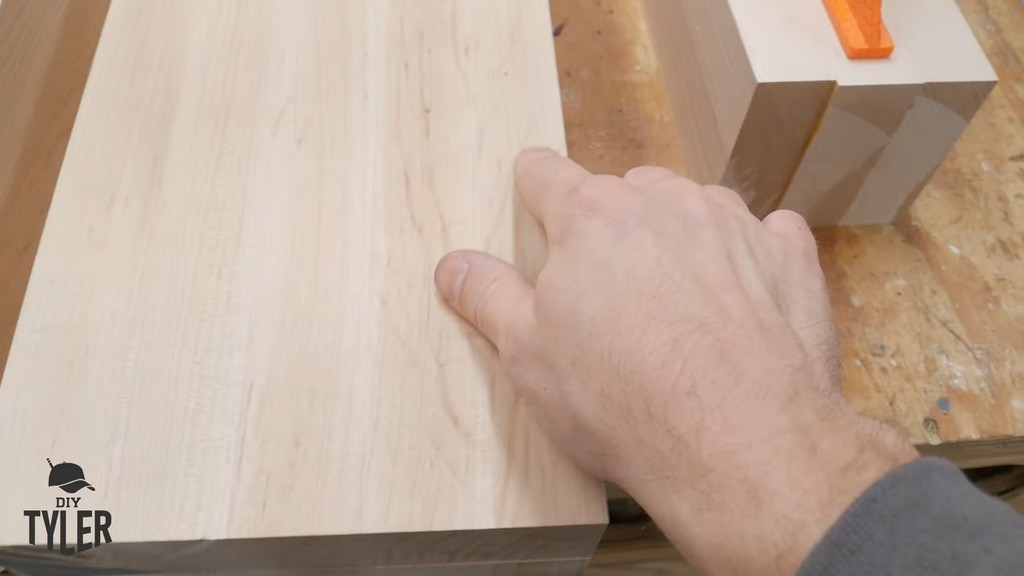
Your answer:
515;148;593;227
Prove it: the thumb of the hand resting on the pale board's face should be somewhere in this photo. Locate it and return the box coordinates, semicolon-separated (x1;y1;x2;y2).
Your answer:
434;250;534;353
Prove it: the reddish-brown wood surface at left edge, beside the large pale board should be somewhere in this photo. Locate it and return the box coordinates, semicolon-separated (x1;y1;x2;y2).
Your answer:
0;0;109;374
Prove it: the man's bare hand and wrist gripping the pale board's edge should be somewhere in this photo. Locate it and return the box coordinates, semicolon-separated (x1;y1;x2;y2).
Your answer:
435;149;916;574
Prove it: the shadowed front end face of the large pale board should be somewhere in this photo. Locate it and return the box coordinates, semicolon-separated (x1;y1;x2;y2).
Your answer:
0;526;604;576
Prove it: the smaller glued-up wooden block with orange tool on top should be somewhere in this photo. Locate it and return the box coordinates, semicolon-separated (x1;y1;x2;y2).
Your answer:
646;0;995;225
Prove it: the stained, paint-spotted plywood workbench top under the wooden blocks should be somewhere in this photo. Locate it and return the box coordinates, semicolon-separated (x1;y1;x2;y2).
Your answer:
551;0;1024;467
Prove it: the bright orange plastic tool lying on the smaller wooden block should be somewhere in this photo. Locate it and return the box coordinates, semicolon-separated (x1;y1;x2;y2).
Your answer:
823;0;895;59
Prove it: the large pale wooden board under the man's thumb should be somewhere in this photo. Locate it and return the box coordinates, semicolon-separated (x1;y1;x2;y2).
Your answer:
0;0;606;575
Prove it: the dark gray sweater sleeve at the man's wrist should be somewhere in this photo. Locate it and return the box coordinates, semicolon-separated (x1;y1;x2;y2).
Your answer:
798;458;1024;576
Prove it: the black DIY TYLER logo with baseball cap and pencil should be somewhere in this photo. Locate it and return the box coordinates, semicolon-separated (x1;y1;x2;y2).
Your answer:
25;458;111;556
